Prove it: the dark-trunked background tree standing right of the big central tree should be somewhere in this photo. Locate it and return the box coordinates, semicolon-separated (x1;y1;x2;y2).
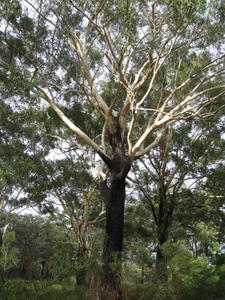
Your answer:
133;99;224;278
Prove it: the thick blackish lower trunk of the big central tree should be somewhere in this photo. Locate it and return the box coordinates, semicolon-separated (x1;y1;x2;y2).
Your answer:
99;153;130;300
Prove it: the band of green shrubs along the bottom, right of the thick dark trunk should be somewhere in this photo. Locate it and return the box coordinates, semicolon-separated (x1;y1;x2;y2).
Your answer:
124;240;225;300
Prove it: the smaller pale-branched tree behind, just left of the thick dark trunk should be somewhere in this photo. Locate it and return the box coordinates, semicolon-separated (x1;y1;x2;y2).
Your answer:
25;146;105;285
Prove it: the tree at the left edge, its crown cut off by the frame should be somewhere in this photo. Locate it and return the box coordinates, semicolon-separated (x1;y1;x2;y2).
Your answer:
0;99;37;246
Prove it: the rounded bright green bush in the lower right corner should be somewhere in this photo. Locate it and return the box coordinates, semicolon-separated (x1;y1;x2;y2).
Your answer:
163;240;219;299
